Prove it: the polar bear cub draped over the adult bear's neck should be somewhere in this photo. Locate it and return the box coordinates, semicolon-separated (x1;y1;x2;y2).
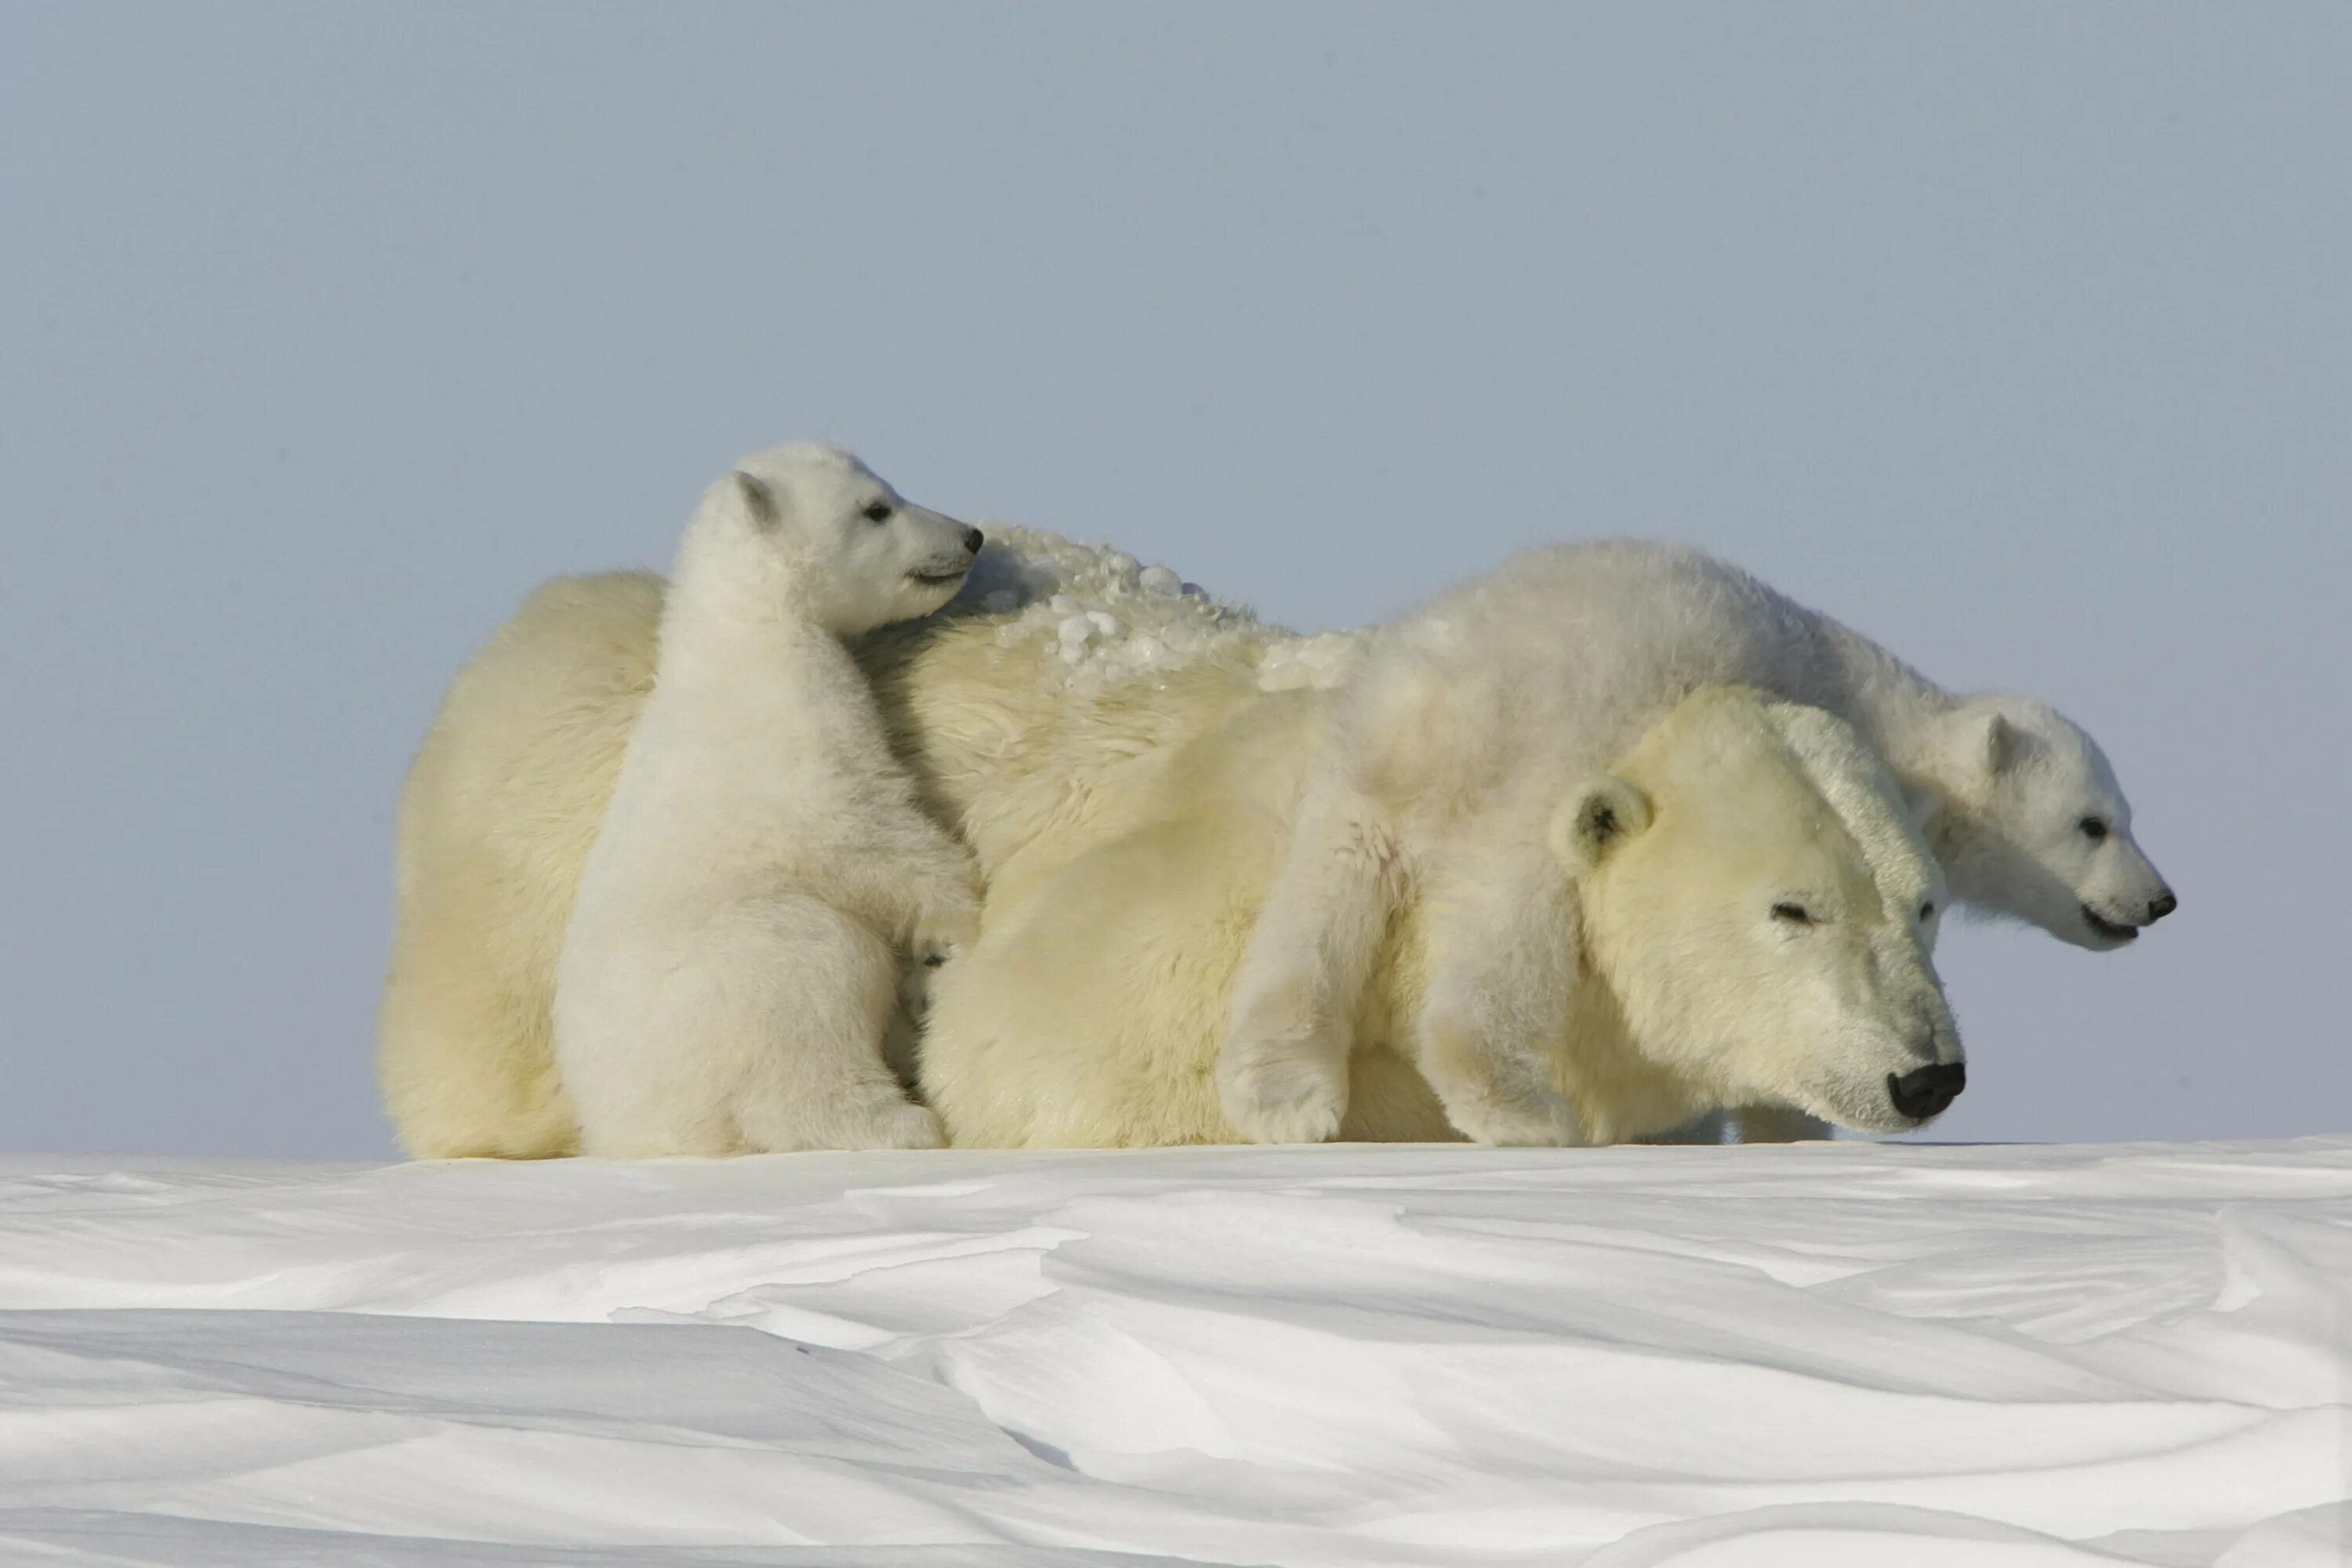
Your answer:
1218;543;2176;1142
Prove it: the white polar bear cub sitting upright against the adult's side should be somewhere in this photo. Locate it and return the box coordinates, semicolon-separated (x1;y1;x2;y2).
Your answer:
553;442;981;1156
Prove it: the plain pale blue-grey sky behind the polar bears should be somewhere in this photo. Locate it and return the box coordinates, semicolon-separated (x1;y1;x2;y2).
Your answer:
0;0;2352;1156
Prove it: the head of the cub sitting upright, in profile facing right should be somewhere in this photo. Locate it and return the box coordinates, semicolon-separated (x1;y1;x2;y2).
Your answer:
680;442;981;637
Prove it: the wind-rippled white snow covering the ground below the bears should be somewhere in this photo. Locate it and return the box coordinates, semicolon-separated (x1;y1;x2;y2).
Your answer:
0;1138;2352;1568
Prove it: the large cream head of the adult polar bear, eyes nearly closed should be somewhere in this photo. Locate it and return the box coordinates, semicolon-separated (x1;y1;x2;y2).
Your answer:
1552;687;1966;1133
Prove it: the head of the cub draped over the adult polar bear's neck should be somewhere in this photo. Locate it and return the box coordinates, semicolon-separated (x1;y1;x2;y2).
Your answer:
1931;696;2180;949
